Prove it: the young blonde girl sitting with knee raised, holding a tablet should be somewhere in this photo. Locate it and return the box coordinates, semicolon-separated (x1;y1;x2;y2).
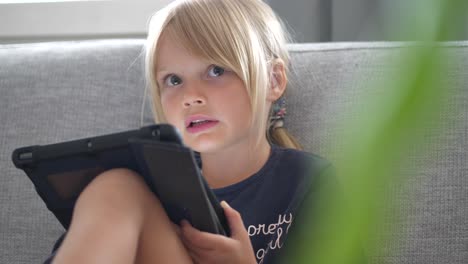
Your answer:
46;0;332;263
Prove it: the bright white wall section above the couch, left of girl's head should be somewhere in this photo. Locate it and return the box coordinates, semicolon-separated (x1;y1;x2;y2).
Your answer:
0;0;171;43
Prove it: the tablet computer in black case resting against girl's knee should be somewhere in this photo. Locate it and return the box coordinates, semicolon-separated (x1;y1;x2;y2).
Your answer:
12;124;230;236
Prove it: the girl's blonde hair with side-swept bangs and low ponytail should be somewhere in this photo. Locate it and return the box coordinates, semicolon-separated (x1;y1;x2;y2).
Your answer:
145;0;300;148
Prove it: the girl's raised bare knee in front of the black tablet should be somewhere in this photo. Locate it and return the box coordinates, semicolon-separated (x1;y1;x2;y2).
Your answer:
58;169;146;263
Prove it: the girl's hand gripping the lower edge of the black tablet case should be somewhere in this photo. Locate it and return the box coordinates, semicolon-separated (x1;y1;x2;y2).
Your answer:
181;201;257;264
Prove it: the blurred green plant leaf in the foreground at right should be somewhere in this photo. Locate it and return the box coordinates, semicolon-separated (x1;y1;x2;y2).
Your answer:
285;0;468;264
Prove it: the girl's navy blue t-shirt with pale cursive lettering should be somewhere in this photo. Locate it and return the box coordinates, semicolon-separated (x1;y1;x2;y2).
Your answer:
45;145;330;264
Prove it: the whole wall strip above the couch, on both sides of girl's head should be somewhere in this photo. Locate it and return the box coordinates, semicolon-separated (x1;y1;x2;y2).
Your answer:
0;0;468;43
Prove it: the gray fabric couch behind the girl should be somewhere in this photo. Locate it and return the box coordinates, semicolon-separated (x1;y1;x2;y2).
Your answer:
0;39;468;264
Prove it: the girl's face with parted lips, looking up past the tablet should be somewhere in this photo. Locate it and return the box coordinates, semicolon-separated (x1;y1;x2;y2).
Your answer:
156;34;257;153
